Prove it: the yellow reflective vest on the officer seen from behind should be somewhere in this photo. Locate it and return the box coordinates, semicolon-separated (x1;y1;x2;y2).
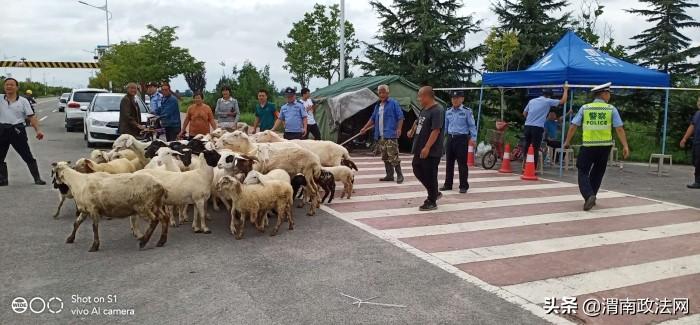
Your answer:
581;102;613;147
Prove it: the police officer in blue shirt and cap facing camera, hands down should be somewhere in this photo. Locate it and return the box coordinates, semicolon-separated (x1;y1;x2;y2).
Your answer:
440;90;476;193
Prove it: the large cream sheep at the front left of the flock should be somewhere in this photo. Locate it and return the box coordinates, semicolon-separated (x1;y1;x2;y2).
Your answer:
52;162;168;252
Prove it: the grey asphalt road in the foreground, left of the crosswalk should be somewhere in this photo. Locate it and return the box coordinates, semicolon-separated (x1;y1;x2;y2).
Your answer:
0;101;545;324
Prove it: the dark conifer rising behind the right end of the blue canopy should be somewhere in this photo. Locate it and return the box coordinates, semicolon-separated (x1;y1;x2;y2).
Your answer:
627;0;700;73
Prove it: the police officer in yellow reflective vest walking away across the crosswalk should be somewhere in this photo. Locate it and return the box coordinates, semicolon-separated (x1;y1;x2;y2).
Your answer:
564;83;630;211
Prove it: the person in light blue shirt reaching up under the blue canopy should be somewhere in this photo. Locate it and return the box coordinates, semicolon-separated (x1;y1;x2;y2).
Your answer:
523;85;569;165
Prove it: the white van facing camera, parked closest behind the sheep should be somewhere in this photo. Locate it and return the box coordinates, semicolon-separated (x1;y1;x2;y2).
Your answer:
83;93;153;148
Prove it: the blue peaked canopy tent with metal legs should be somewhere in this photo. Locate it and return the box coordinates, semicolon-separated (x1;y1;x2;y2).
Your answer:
478;31;671;176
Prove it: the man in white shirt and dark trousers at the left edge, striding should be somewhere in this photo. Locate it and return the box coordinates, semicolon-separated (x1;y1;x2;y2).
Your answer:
0;78;46;186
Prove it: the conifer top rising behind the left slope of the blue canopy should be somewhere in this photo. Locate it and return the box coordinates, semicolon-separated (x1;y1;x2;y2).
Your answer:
492;0;571;70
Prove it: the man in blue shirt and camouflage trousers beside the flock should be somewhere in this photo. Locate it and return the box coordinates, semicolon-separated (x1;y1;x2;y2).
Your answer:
360;85;404;184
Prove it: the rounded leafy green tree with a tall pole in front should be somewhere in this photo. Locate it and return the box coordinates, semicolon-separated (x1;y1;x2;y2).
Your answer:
277;4;359;87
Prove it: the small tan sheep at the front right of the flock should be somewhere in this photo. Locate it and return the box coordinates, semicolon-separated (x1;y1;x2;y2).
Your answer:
217;176;294;239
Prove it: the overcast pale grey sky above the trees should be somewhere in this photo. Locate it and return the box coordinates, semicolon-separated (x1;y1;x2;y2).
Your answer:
0;0;700;90
